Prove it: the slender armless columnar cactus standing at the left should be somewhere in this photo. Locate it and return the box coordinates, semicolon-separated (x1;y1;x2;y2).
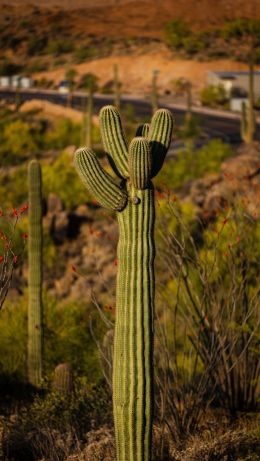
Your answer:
28;160;43;386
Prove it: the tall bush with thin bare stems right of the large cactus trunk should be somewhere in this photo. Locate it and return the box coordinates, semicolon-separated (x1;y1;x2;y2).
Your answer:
157;202;260;415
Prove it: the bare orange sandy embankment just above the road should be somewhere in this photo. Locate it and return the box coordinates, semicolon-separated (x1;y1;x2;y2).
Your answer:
34;49;254;94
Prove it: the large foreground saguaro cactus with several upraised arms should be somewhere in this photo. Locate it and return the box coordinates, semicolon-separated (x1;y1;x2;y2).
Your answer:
75;106;173;461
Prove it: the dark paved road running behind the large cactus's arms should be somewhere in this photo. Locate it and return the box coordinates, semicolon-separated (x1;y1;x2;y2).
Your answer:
0;89;260;144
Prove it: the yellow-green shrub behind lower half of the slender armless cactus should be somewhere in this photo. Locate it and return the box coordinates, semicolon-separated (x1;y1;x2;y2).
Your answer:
0;292;104;384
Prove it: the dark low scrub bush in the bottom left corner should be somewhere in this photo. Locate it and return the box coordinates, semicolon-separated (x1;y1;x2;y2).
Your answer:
3;378;111;461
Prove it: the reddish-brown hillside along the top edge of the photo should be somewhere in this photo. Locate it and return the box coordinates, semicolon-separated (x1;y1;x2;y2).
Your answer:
0;0;260;38
